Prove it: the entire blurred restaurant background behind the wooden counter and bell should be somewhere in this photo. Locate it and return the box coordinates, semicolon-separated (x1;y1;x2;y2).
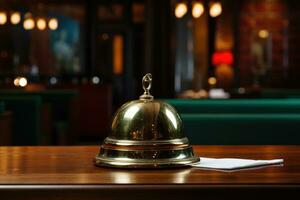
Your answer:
0;0;300;145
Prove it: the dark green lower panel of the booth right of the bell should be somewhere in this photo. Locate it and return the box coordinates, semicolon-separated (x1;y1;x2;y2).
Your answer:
181;113;300;145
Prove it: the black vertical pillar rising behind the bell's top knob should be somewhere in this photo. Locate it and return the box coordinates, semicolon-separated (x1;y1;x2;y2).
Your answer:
144;0;174;97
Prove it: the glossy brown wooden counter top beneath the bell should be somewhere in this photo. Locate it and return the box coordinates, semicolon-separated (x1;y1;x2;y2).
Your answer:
0;146;300;199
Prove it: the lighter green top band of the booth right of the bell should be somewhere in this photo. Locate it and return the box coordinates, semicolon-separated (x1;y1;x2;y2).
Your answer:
166;99;300;114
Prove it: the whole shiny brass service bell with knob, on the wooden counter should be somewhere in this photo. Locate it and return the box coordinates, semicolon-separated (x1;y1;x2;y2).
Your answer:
94;74;199;168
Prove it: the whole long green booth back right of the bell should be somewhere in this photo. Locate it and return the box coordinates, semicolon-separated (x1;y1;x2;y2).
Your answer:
166;98;300;145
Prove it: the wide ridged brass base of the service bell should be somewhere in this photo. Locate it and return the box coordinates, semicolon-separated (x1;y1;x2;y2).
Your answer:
94;146;200;168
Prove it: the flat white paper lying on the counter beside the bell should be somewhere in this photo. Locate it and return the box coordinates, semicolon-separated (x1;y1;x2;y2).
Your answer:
190;157;284;170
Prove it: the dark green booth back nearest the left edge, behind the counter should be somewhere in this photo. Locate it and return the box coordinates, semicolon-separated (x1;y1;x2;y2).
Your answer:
0;95;42;145
